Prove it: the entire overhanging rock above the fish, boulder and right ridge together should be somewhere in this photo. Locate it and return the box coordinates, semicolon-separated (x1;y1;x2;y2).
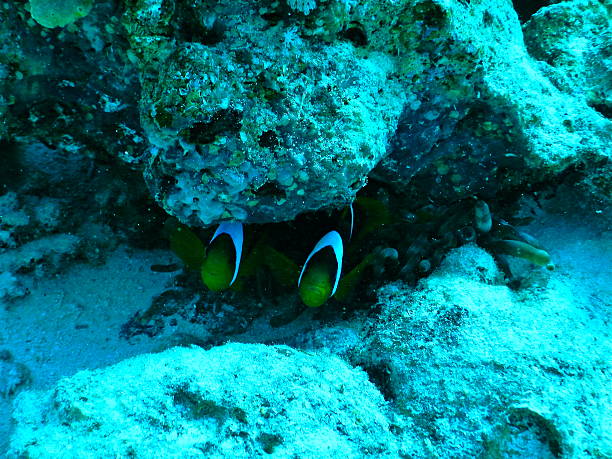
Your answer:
125;0;612;225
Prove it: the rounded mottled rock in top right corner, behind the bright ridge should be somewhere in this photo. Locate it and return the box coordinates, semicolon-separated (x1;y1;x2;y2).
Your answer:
523;0;612;204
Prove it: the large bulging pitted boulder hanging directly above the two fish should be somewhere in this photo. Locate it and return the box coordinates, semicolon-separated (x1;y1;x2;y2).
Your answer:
124;0;405;226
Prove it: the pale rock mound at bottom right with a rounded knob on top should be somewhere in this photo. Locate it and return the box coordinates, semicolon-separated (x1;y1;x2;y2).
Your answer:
364;246;612;458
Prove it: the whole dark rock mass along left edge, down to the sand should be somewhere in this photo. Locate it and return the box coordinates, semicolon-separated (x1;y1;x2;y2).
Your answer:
0;0;166;300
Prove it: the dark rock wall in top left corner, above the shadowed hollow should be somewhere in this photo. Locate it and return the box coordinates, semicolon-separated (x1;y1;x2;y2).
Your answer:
0;0;145;164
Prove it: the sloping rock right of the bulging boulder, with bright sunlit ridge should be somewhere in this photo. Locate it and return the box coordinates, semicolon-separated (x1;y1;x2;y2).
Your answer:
374;1;612;203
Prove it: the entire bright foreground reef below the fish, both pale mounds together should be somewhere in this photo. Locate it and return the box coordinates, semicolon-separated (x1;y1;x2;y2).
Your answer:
10;245;612;458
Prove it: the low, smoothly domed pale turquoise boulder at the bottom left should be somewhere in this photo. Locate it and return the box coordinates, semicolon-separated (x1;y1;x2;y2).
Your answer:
12;344;397;458
